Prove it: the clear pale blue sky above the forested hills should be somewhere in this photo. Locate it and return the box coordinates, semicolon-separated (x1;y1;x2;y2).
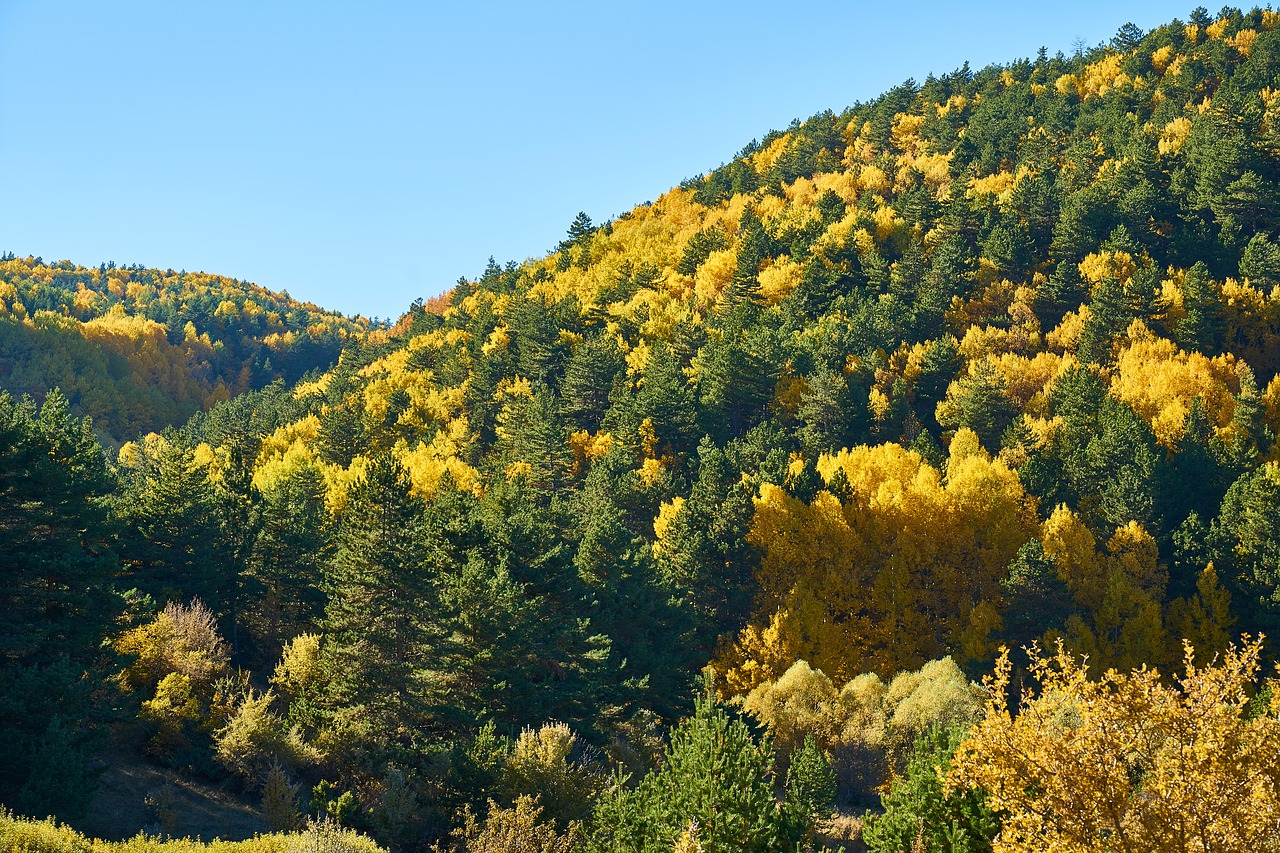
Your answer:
0;0;1192;318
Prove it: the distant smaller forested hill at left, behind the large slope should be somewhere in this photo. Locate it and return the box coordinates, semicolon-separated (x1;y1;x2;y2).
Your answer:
0;254;369;444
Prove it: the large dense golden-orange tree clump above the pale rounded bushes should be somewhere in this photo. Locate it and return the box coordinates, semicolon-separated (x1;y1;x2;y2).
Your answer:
722;429;1034;693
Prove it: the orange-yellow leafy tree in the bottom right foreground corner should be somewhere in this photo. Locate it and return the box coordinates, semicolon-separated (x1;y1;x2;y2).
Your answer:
950;638;1280;853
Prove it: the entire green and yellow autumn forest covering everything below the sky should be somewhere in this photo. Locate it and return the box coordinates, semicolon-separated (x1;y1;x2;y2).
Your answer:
0;6;1280;853
